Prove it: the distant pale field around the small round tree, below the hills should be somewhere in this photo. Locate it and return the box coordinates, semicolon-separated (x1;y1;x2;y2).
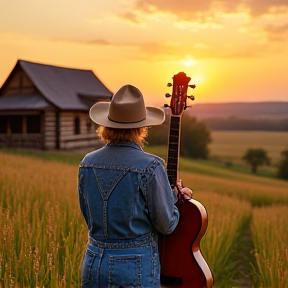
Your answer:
146;131;288;178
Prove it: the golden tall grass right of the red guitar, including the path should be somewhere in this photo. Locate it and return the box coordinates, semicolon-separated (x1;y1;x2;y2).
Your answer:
180;167;288;288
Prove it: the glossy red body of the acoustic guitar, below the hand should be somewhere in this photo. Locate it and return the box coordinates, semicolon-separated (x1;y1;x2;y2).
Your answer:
159;199;213;288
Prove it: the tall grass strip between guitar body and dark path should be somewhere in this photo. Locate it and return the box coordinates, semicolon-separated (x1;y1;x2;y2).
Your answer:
195;193;252;288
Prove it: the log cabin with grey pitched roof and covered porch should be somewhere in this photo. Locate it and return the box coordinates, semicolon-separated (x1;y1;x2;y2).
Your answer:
0;60;113;150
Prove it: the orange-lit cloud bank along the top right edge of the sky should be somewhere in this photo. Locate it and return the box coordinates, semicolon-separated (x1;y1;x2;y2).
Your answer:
117;0;288;24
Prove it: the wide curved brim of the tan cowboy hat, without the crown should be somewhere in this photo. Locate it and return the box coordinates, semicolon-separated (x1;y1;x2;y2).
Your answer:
89;102;165;129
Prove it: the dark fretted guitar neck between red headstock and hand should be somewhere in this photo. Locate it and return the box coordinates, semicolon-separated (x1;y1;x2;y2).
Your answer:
167;115;181;186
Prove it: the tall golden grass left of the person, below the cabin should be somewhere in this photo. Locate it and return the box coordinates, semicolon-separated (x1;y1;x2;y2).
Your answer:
0;153;87;288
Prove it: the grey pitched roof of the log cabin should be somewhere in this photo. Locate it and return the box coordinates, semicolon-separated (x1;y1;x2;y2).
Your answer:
0;60;112;110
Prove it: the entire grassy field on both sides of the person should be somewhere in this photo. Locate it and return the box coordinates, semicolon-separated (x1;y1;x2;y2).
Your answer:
0;132;288;288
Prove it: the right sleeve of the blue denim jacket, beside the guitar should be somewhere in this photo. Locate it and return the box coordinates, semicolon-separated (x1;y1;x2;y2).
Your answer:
147;165;180;234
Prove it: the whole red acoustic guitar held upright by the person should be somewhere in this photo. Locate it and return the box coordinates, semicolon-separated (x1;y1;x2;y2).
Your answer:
159;72;213;288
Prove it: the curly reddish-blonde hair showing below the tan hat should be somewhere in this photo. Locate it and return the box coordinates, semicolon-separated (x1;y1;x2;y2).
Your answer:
96;126;148;147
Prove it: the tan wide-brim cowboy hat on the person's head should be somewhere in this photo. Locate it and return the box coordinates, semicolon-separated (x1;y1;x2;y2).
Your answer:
89;84;165;129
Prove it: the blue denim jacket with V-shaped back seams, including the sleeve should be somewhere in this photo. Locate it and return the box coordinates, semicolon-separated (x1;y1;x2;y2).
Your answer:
79;142;179;241
